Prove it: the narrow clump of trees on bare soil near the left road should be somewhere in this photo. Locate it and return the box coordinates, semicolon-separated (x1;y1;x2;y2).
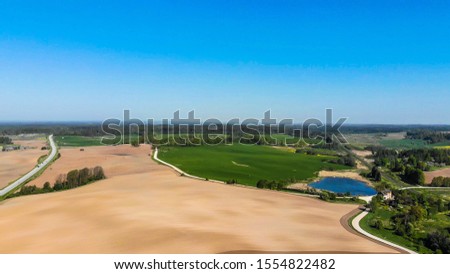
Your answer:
9;166;106;198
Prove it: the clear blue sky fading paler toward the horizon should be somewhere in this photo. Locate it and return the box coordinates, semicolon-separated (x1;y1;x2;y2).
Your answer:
0;0;450;124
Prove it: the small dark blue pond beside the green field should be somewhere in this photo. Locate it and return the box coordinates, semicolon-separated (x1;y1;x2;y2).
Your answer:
310;177;377;196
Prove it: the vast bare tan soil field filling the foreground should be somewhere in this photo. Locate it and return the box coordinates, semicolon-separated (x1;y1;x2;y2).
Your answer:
0;146;396;253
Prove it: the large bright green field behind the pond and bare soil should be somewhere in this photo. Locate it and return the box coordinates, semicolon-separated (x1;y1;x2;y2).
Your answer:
158;144;348;186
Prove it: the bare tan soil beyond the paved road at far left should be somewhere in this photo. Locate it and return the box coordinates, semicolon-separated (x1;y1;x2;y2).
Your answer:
0;140;48;188
